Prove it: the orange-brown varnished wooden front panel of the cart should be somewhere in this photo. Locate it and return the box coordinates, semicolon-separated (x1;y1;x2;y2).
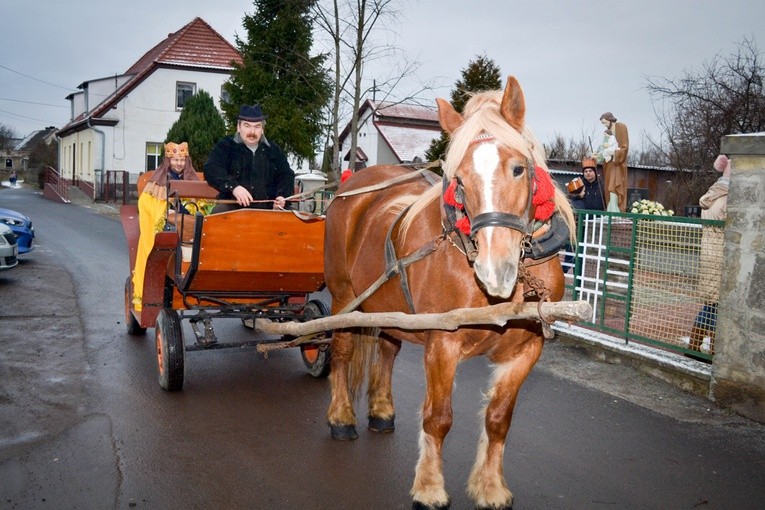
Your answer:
177;209;324;294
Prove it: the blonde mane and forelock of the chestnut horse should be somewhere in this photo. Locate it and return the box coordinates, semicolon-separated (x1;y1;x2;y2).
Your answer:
401;90;576;240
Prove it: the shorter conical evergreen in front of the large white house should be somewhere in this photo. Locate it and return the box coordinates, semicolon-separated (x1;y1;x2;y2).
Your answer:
165;90;226;172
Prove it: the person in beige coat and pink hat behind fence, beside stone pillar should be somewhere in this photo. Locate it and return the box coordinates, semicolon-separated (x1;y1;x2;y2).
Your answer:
688;154;731;354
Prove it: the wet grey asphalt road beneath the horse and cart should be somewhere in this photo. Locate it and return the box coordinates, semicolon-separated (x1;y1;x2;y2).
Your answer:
0;185;765;510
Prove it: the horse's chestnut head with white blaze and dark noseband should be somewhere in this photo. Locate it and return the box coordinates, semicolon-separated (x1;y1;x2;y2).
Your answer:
437;76;544;298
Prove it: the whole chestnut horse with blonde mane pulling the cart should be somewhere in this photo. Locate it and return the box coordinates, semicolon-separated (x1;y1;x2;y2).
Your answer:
325;77;573;509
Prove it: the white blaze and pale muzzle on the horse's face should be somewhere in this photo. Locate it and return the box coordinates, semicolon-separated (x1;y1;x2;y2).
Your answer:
470;141;522;299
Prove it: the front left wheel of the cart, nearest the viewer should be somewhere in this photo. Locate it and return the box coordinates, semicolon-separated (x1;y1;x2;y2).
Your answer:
154;308;186;391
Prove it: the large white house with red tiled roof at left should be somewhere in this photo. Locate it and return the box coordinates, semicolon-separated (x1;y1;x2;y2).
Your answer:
58;18;242;192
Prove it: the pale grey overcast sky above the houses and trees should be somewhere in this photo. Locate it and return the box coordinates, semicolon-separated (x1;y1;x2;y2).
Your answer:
0;0;765;152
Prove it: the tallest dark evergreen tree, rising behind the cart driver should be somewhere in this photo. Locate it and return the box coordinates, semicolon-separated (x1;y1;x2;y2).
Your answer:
222;0;331;160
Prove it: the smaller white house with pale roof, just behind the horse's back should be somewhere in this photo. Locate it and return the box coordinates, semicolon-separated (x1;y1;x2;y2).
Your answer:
340;99;441;170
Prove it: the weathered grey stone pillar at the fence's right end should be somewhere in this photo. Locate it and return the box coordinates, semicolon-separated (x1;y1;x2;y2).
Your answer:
709;132;765;423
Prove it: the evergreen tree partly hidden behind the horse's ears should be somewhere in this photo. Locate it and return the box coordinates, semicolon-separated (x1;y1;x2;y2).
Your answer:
425;55;502;161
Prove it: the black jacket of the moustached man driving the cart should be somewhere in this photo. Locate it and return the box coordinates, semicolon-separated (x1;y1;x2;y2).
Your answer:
204;133;295;209
